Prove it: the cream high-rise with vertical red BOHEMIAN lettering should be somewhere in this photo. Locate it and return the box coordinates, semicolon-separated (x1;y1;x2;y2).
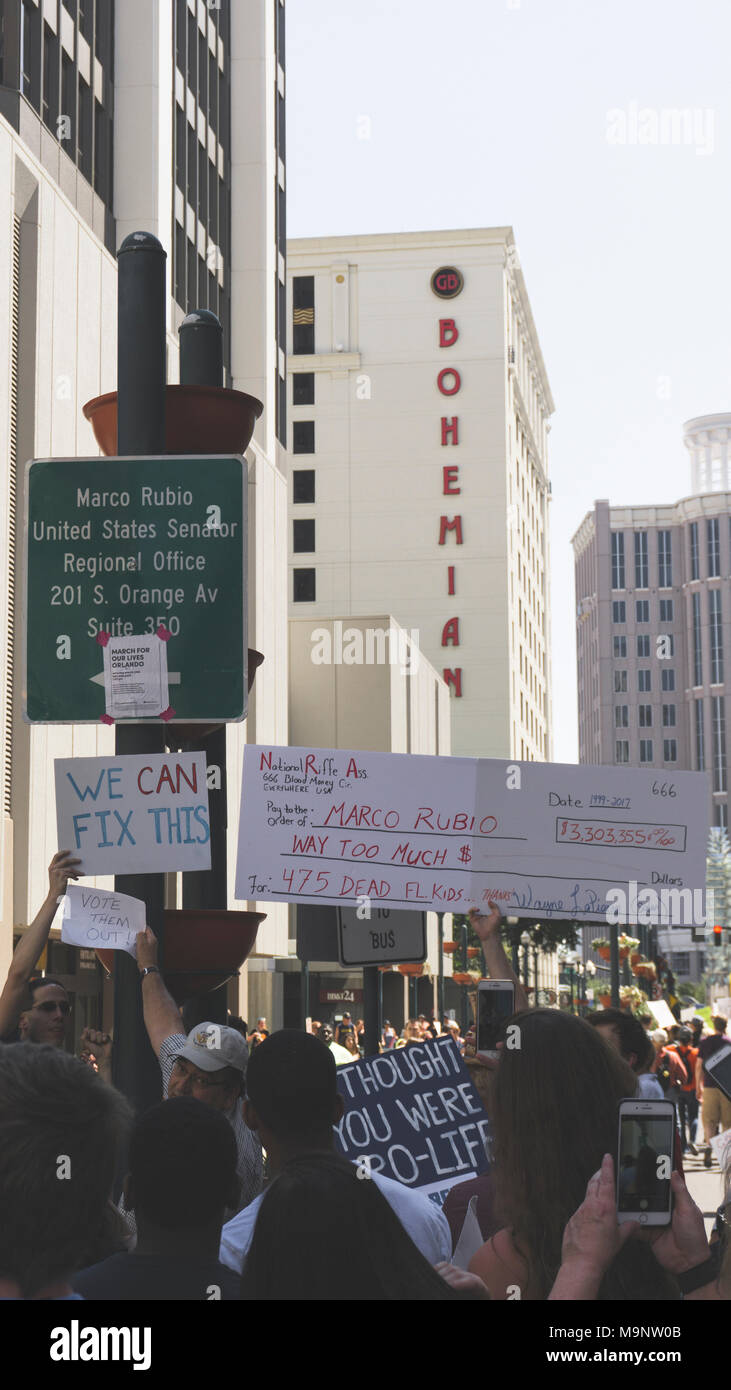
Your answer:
288;228;553;759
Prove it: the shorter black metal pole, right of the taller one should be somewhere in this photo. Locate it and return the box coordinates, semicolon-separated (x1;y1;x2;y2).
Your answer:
178;309;228;1027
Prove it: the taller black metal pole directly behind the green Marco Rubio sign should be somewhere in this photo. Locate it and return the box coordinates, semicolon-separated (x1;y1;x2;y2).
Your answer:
113;232;165;1111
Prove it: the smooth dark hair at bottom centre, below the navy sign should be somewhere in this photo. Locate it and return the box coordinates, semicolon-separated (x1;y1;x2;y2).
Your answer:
242;1150;460;1302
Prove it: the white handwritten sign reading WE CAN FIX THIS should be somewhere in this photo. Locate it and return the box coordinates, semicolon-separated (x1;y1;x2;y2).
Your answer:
54;753;211;874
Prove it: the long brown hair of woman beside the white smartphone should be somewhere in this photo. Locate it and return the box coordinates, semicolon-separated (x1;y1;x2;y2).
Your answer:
491;1009;678;1300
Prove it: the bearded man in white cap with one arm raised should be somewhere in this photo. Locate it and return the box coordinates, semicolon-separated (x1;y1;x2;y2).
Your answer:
138;927;264;1219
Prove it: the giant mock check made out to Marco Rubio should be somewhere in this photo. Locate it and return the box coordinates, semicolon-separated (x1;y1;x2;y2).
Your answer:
236;745;707;924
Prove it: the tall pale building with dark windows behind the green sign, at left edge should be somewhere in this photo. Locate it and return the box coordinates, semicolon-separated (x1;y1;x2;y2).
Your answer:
0;0;288;1027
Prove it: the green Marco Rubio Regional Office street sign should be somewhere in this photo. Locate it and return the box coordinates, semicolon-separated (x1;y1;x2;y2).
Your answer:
24;455;247;724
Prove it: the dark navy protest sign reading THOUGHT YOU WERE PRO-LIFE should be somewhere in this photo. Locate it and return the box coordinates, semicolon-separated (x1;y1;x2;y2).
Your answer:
335;1038;489;1205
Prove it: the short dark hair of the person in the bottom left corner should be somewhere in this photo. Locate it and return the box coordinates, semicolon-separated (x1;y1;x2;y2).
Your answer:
0;1039;131;1298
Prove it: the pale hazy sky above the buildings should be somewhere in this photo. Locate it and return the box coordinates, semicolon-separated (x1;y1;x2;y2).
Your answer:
286;0;731;762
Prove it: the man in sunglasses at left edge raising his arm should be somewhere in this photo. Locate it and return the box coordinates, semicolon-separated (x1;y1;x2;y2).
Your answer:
0;849;81;1047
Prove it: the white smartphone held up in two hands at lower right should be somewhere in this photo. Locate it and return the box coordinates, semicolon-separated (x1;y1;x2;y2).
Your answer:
617;1101;675;1226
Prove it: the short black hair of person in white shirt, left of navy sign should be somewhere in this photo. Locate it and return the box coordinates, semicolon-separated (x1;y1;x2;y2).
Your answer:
246;1029;338;1141
